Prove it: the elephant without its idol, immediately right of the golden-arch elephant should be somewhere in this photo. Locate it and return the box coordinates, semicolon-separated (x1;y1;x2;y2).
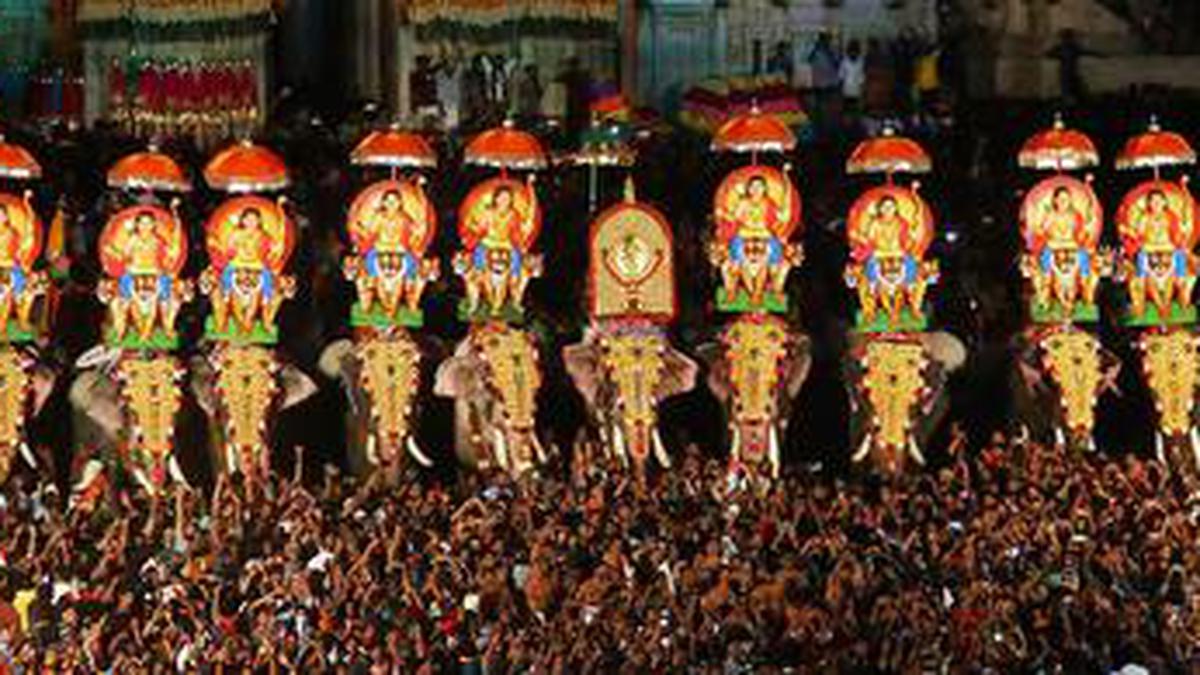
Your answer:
703;315;812;477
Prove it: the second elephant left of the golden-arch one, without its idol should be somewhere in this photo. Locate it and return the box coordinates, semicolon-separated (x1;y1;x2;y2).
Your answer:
320;330;433;483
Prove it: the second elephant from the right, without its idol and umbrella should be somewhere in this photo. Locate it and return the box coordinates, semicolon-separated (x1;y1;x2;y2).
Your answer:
1013;325;1121;450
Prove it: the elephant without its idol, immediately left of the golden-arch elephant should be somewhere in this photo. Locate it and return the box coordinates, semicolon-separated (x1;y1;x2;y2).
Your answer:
433;323;545;476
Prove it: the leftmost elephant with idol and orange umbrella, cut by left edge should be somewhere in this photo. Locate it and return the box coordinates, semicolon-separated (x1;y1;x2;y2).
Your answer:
0;135;55;483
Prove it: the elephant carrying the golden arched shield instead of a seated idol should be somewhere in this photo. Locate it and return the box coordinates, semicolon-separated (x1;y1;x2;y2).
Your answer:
563;179;697;480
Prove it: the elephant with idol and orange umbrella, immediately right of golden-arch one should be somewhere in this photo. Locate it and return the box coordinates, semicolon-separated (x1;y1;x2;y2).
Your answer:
708;107;809;478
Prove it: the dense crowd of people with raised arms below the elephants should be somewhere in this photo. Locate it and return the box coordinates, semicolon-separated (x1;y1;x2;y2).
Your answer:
0;438;1200;674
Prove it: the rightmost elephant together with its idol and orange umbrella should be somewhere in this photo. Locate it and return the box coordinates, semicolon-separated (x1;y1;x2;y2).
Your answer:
1116;121;1200;474
